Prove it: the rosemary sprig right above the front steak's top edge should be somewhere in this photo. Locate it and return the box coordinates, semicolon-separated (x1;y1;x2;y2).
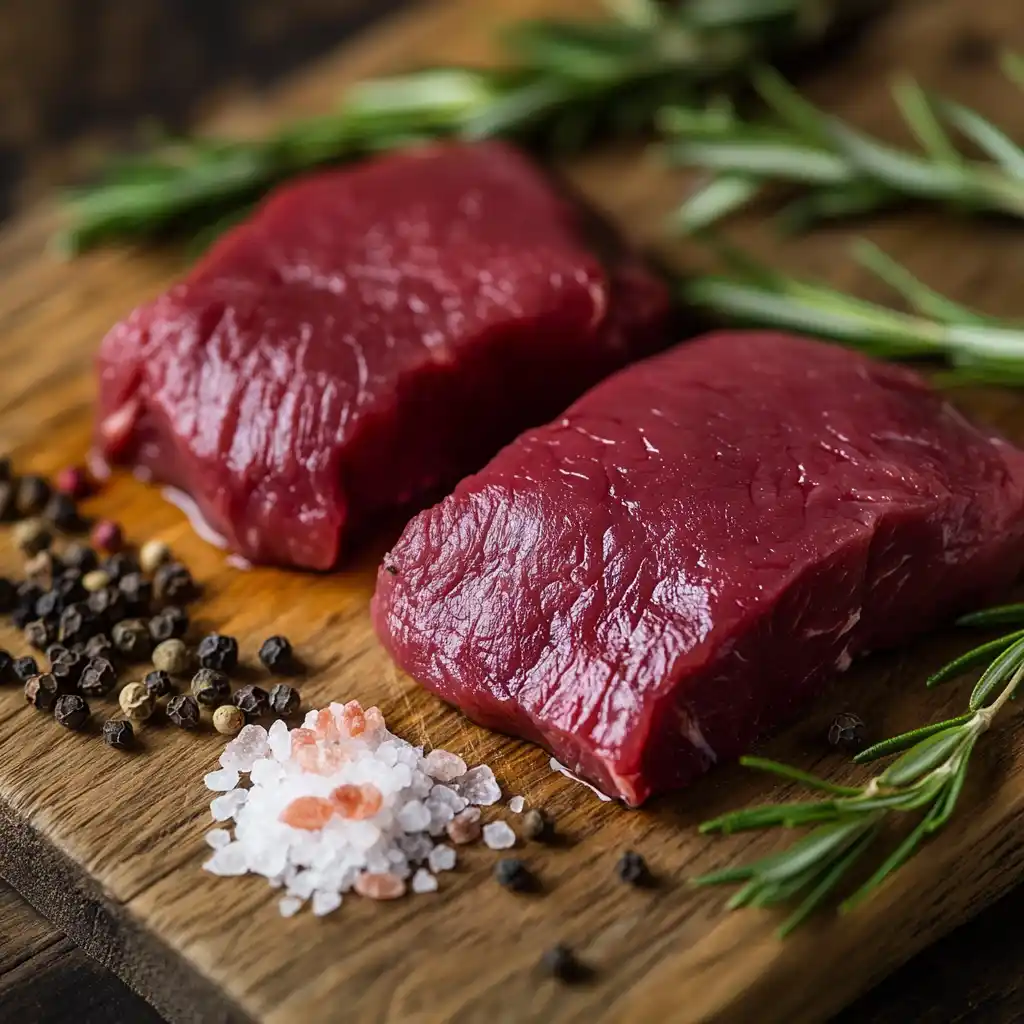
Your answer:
680;238;1024;386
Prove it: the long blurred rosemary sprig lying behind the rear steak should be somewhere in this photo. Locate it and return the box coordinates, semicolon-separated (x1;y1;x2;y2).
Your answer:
61;0;851;252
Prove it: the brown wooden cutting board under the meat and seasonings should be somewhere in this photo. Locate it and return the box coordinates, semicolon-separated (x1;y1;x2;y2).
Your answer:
0;0;1024;1024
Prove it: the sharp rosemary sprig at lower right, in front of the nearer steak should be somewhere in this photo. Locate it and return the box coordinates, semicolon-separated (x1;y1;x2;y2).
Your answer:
693;605;1024;935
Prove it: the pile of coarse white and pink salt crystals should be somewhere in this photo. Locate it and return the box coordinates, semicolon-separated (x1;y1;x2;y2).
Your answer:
203;700;503;918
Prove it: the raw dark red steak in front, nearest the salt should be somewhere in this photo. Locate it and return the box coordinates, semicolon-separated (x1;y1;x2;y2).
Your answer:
374;333;1024;805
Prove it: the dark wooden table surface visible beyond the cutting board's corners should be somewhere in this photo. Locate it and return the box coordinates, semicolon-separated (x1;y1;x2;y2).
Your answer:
0;0;1024;1024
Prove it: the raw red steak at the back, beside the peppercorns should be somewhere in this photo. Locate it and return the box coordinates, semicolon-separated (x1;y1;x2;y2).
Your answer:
97;143;669;568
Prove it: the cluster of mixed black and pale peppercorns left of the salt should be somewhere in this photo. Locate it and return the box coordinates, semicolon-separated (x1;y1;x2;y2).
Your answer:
0;459;300;750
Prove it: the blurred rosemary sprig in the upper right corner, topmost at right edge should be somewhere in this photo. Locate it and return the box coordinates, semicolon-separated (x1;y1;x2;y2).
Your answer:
658;55;1024;230
